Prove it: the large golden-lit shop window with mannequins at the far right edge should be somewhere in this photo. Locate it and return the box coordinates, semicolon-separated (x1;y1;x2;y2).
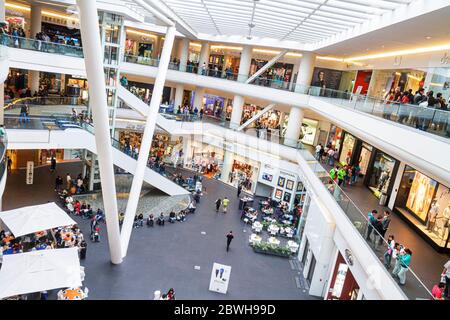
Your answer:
394;166;450;253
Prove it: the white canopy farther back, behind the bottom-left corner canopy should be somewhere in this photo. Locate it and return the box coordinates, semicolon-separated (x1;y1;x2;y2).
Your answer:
0;202;76;237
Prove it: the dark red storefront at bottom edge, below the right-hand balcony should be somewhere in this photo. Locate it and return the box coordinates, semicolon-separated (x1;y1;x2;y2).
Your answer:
327;252;360;300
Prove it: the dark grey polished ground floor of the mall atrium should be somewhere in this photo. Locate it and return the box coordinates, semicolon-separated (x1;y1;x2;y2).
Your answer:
3;163;317;299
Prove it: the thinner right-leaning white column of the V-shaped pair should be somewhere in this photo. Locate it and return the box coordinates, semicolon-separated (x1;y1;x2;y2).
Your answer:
121;26;176;256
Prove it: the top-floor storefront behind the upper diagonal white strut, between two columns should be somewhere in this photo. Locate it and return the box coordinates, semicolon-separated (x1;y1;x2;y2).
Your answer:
250;59;294;89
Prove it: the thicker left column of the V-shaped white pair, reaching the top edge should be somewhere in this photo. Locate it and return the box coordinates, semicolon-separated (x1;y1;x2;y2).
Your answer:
77;0;122;264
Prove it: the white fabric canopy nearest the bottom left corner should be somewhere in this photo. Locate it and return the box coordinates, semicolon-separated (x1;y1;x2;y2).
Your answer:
0;248;81;299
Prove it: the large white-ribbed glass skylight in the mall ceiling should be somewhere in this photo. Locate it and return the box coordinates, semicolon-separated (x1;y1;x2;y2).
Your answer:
152;0;415;43
